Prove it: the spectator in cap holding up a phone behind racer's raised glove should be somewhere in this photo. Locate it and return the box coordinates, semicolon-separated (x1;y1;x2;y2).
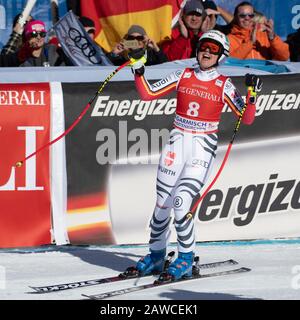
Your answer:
107;25;168;66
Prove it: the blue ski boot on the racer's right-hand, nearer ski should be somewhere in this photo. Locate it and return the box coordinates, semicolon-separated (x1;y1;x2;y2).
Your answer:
167;251;194;280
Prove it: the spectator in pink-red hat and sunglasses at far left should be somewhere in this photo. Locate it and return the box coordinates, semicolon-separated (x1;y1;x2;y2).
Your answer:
19;20;64;67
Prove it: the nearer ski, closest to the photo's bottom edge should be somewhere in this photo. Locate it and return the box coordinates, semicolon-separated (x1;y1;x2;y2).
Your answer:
82;267;251;300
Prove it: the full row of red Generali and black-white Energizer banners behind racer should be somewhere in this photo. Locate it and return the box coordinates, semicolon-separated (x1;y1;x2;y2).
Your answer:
0;72;300;247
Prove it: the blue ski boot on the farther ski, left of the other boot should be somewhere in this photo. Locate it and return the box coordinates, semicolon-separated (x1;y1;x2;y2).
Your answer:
136;249;166;275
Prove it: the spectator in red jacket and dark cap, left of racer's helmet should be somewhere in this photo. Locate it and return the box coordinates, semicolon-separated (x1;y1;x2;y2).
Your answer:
162;0;206;61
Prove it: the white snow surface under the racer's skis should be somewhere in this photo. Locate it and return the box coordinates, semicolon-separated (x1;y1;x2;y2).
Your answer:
0;239;300;300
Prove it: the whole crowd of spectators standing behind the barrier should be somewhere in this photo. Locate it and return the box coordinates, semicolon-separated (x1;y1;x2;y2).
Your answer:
0;0;300;67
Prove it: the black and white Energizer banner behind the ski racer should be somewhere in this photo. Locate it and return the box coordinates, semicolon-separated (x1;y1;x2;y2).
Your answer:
63;71;300;244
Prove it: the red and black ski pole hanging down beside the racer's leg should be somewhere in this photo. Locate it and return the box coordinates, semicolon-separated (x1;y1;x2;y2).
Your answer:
186;99;251;220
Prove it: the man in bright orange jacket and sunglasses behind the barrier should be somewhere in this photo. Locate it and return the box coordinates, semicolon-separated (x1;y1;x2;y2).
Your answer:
228;1;289;61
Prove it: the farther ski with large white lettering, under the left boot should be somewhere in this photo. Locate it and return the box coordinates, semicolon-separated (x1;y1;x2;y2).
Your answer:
30;259;237;293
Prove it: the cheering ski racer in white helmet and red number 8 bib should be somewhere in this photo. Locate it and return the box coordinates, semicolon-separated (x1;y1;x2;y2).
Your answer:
132;30;262;280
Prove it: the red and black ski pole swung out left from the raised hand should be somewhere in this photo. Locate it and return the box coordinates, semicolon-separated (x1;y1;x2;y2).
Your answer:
15;60;131;168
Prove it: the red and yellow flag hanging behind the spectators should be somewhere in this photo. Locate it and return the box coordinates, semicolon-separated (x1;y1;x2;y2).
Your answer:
81;0;184;51
